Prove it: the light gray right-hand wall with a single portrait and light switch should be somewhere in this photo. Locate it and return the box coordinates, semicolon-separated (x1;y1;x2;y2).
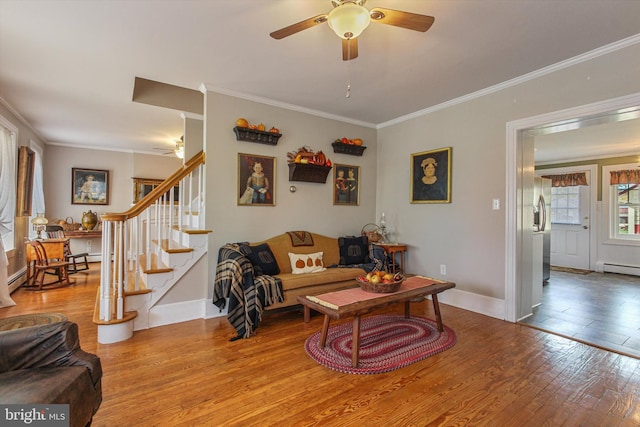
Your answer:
377;39;640;311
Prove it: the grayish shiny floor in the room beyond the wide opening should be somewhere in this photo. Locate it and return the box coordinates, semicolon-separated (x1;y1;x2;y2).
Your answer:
522;271;640;359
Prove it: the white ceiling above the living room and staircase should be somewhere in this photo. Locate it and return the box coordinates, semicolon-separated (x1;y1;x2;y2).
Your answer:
0;0;640;160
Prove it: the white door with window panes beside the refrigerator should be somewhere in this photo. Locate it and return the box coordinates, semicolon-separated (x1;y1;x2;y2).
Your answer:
551;171;595;270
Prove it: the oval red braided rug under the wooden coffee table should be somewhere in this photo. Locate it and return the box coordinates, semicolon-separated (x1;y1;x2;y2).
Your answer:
305;315;456;374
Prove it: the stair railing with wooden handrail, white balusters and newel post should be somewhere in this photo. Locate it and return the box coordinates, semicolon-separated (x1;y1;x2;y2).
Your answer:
94;151;205;323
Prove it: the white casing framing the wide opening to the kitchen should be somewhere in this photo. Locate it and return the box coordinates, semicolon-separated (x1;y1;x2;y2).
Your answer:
505;94;640;322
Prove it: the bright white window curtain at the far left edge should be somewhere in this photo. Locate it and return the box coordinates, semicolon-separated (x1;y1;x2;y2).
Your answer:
0;126;17;307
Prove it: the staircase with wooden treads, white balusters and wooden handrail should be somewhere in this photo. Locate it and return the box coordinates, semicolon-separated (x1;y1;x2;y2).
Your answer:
93;152;210;344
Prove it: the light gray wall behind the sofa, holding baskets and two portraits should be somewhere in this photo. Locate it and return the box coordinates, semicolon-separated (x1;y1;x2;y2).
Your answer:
205;92;376;294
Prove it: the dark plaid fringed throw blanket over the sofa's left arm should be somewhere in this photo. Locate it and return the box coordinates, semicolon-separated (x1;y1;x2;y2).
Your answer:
213;243;284;341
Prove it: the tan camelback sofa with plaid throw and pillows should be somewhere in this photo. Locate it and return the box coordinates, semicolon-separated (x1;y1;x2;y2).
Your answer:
213;231;384;339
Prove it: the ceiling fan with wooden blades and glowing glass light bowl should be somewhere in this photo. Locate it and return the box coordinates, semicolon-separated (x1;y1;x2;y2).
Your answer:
270;0;435;61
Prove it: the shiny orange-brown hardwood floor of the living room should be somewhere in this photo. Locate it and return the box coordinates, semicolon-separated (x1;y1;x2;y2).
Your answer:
0;264;640;427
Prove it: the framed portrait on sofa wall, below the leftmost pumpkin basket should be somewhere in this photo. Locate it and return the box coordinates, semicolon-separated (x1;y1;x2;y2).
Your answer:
237;153;276;206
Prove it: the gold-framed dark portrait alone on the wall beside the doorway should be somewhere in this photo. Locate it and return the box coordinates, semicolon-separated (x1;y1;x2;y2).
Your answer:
411;147;451;203
